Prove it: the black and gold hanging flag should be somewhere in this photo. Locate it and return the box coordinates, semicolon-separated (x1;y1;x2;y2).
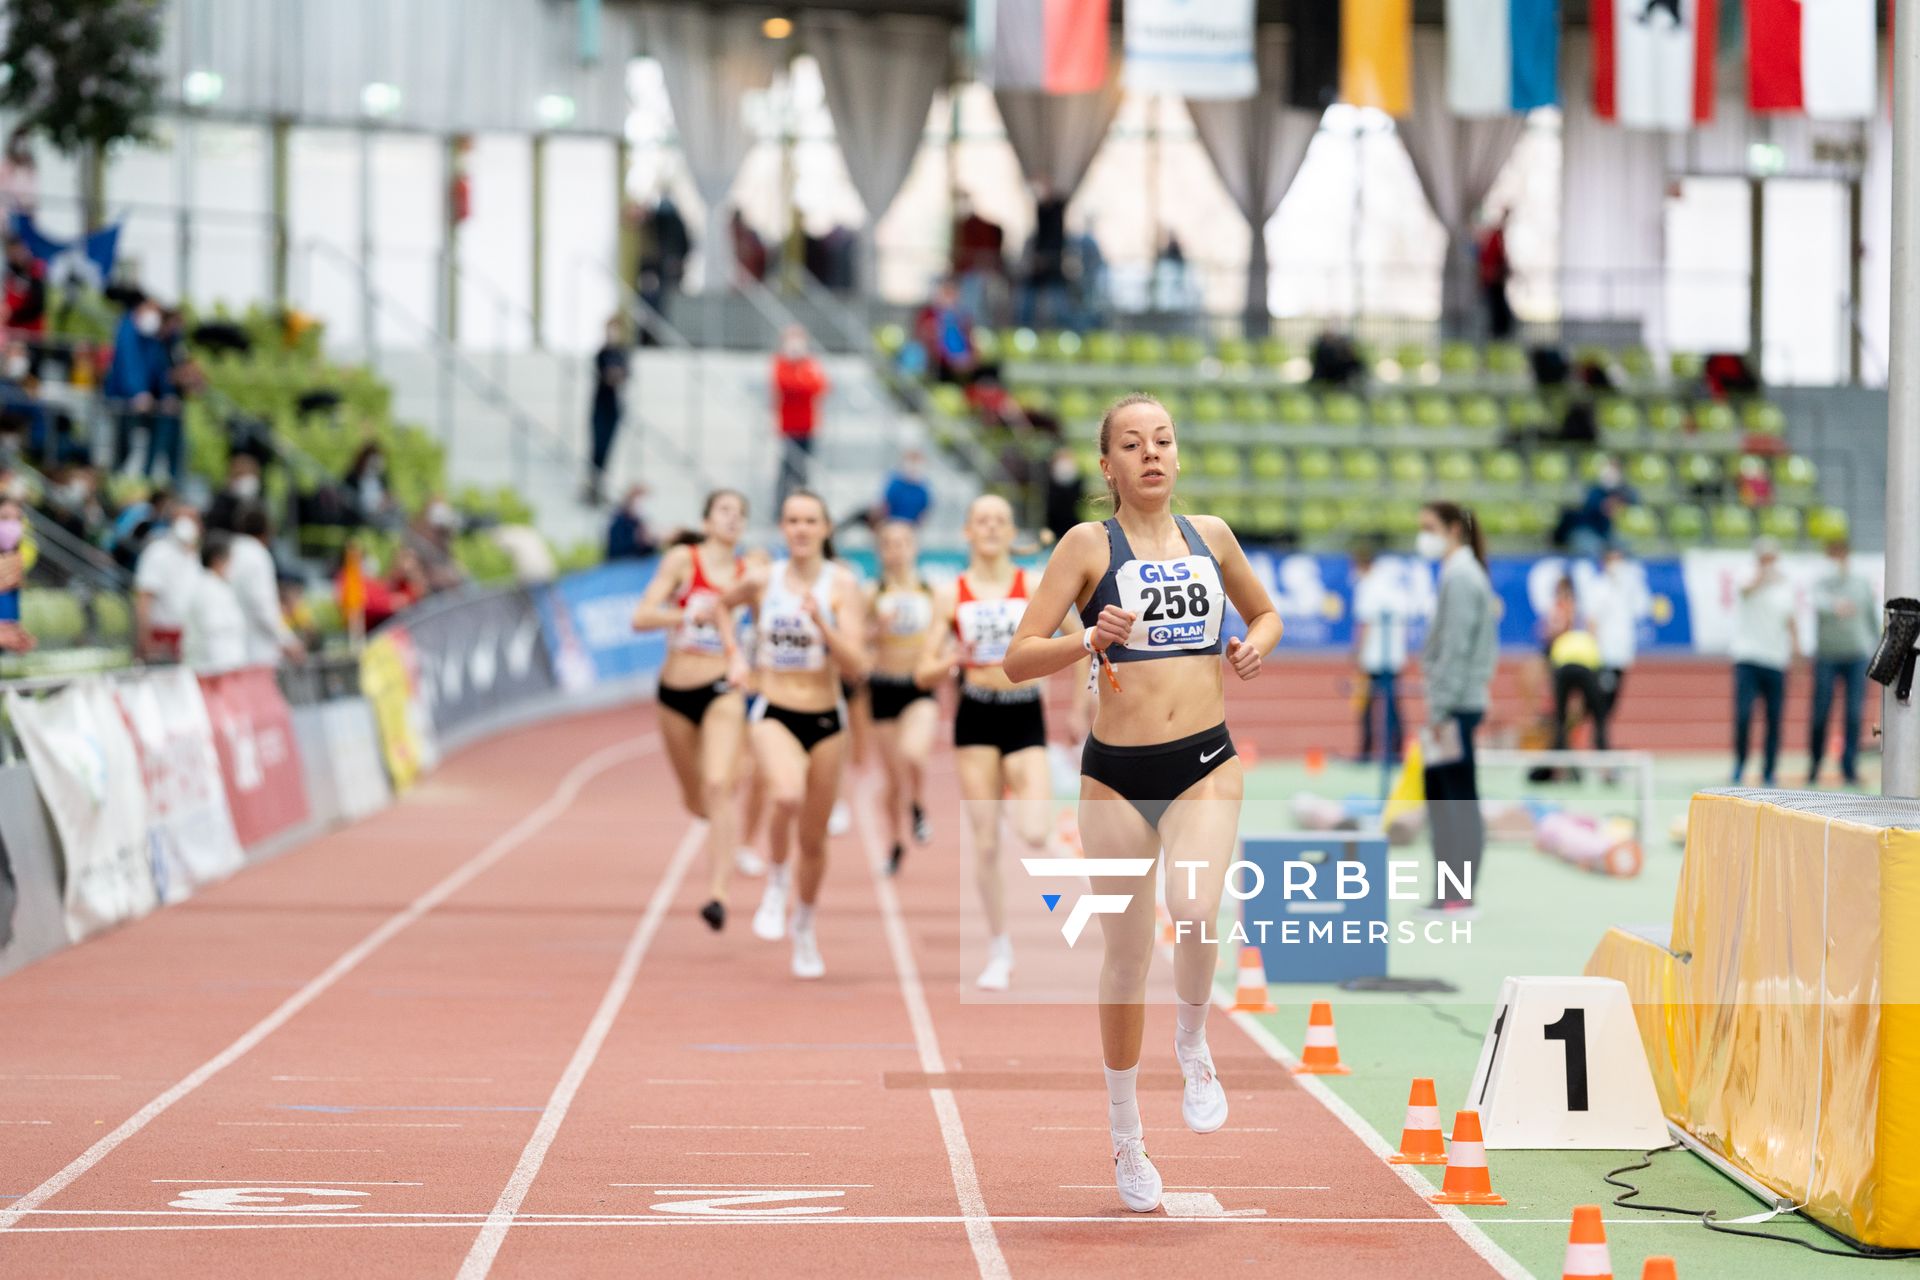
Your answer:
1290;0;1413;115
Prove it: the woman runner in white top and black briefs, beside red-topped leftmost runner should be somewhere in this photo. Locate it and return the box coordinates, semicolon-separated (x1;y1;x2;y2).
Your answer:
745;489;866;979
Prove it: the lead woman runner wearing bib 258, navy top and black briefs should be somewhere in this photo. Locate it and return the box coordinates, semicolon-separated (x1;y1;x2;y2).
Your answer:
1006;395;1281;1213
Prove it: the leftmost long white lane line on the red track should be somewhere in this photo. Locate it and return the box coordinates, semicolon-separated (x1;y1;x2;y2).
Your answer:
0;735;660;1232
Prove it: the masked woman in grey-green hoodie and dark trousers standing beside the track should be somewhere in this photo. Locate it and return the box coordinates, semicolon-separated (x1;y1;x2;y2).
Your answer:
1413;503;1500;919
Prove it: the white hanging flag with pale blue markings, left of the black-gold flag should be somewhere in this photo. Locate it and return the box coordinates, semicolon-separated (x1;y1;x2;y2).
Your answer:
1121;0;1260;100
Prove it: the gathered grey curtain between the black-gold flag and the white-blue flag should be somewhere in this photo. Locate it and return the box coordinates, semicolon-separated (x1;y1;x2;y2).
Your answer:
1394;31;1526;320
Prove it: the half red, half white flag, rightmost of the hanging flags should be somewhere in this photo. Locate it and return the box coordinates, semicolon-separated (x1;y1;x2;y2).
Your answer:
1747;0;1878;121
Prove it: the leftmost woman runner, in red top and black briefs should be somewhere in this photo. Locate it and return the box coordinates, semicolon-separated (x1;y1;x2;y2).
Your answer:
634;489;747;933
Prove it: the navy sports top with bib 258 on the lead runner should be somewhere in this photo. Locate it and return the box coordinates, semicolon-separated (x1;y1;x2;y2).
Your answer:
1081;516;1227;662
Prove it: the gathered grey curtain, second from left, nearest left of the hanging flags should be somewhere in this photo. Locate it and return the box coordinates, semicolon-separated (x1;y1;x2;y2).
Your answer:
806;12;950;288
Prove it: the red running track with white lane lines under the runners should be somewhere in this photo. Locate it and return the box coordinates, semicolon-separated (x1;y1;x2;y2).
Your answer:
0;710;1521;1278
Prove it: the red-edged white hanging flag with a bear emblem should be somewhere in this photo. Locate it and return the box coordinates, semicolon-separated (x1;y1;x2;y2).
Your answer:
1590;0;1718;130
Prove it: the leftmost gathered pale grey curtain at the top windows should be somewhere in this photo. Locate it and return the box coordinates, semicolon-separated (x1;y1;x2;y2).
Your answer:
645;6;787;290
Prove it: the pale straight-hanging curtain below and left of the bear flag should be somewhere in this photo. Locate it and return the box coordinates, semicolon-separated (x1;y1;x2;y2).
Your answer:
1561;31;1667;347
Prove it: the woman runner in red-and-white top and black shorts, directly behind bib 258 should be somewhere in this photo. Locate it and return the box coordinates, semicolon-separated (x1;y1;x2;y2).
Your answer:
920;493;1085;990
